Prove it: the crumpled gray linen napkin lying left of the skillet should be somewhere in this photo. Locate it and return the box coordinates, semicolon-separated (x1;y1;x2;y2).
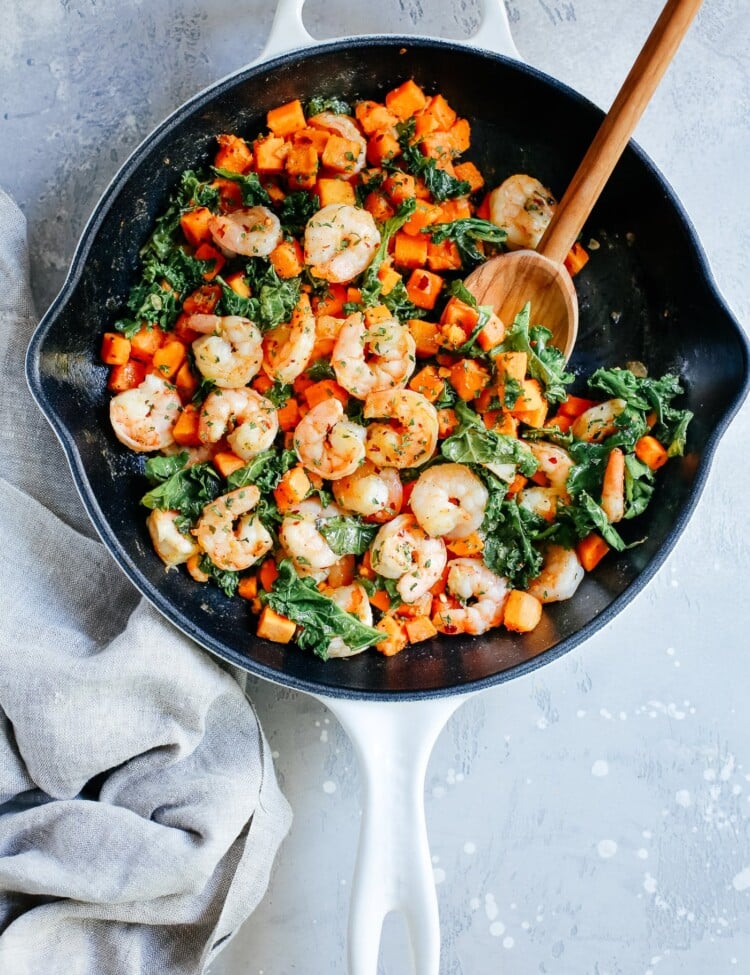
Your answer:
0;190;291;975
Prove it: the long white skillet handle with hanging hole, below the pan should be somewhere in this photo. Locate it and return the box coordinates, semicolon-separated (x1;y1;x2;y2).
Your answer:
319;696;466;975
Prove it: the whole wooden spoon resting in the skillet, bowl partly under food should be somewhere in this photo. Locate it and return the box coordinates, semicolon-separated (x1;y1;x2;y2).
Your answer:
465;0;703;359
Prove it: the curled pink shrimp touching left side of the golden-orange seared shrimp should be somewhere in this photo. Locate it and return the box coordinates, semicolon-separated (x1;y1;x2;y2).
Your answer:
294;397;367;481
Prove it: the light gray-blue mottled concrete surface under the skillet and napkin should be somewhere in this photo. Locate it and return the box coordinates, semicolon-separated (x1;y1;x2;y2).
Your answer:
0;0;750;975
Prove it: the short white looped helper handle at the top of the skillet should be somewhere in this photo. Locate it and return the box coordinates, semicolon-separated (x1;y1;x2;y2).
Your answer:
258;0;522;62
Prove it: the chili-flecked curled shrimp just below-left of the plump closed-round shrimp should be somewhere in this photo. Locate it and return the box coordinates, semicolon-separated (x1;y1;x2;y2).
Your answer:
370;515;448;603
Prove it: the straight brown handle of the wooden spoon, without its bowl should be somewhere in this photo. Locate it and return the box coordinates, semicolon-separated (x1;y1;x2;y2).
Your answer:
537;0;703;264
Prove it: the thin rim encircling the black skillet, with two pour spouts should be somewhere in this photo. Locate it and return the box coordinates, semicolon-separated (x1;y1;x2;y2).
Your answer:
25;34;750;701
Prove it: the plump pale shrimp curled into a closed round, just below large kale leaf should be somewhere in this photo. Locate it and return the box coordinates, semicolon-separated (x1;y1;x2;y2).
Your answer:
409;464;489;541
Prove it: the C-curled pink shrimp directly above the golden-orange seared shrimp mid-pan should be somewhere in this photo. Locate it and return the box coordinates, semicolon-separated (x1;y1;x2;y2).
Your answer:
331;312;417;399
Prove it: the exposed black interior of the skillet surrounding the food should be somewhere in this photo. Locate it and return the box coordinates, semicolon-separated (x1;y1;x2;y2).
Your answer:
28;37;748;699
